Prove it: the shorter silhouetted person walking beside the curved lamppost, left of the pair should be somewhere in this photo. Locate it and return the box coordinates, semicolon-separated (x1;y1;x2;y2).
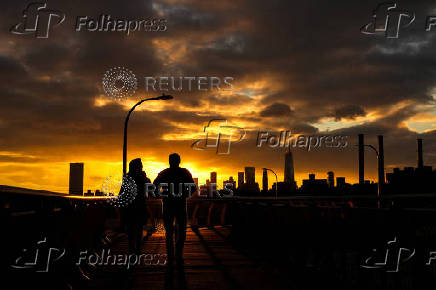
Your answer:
122;158;151;254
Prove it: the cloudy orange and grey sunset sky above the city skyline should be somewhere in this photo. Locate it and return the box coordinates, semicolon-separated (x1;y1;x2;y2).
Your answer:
0;0;436;193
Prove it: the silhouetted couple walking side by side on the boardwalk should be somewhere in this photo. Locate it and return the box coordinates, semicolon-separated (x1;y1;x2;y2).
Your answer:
127;153;196;265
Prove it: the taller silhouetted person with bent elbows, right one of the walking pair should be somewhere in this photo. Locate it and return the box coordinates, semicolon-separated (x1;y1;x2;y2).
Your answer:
153;153;196;265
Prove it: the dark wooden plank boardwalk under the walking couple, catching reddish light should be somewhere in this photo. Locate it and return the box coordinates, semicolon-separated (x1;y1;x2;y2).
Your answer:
88;225;292;290
